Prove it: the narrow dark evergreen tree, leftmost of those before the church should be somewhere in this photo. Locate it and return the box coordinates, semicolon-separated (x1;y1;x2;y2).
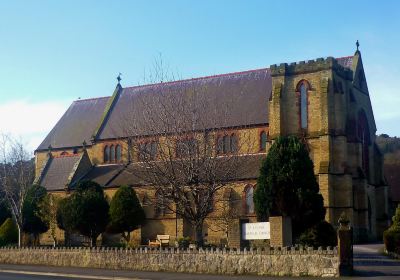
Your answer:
22;185;49;243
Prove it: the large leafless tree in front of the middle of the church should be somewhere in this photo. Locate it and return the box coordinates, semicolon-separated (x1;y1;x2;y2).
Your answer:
111;59;254;244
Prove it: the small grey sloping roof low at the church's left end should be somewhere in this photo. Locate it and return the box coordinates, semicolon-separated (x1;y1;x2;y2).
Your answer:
39;155;81;191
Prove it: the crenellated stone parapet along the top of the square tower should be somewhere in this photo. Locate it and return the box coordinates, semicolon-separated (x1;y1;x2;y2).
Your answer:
270;56;353;80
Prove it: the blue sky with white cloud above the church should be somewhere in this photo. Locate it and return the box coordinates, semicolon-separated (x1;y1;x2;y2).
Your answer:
0;0;400;153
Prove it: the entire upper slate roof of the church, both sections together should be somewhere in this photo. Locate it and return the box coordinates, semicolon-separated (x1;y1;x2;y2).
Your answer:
37;56;353;150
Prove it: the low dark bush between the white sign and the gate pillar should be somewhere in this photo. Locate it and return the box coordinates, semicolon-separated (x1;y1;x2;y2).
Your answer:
297;221;337;248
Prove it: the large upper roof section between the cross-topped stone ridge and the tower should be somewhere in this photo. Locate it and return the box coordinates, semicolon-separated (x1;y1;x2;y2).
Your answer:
99;68;272;139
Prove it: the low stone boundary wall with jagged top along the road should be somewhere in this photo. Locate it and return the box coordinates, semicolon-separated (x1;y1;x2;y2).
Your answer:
0;247;339;277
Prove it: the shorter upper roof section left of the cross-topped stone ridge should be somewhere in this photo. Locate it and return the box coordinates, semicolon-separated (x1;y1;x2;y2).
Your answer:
37;97;109;150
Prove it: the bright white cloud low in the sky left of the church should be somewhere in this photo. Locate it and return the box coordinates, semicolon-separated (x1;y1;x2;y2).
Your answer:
0;99;70;152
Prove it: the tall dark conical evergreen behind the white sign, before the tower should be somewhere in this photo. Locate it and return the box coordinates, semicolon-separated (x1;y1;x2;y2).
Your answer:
254;136;325;239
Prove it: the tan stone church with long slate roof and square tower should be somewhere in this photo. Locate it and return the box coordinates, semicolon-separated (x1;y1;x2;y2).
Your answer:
35;50;388;246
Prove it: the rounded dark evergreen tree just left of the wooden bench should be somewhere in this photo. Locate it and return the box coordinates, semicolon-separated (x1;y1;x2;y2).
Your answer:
110;186;146;244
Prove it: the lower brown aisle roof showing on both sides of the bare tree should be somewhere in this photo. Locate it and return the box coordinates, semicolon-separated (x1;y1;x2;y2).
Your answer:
83;154;265;188
